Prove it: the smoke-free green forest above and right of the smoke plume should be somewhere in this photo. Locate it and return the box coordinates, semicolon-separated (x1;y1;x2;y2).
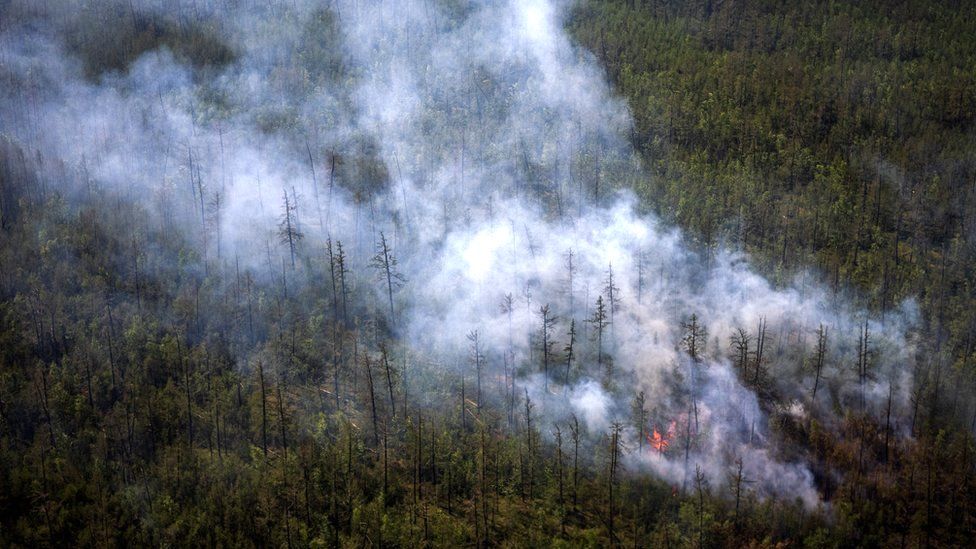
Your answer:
569;0;976;360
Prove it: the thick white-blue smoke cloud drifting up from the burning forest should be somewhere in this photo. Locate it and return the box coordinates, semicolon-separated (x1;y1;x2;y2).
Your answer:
0;0;914;506
